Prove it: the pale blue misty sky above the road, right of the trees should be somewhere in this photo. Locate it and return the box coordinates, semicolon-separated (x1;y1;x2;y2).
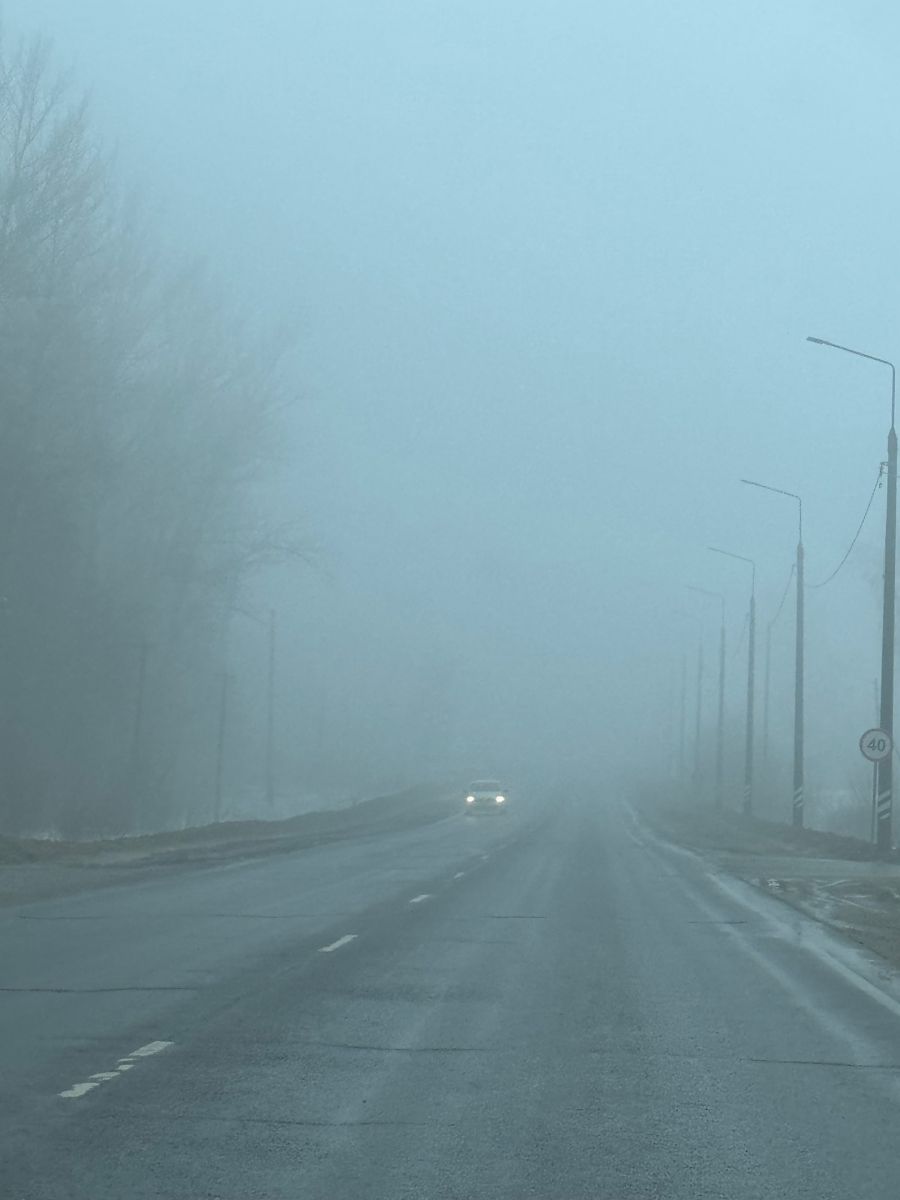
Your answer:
2;0;900;796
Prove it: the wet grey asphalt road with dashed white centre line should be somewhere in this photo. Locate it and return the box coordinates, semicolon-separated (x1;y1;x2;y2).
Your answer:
0;797;900;1200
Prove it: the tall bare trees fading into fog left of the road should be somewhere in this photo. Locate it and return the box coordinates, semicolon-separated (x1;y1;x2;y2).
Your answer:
0;32;303;835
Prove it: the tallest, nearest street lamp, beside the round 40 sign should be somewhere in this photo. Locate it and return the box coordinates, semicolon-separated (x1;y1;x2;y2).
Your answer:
806;337;896;853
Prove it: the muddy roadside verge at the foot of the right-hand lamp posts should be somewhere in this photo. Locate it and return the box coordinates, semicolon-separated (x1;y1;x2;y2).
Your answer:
638;805;900;966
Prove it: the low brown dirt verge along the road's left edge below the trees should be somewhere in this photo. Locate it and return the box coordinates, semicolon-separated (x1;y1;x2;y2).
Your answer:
0;787;458;905
